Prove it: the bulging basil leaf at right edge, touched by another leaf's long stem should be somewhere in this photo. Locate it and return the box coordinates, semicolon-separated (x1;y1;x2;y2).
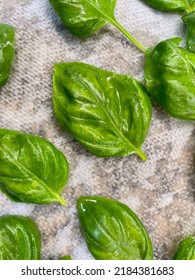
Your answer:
145;38;195;120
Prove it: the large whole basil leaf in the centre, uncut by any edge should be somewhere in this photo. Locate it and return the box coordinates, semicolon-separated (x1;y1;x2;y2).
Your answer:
53;62;151;160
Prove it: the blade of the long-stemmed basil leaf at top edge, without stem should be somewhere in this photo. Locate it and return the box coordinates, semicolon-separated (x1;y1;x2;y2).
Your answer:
50;0;116;37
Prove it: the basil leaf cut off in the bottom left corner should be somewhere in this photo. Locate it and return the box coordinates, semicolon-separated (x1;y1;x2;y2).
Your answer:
0;216;41;260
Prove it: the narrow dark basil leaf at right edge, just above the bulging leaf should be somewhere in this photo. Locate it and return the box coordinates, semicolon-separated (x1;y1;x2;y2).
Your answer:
182;12;195;53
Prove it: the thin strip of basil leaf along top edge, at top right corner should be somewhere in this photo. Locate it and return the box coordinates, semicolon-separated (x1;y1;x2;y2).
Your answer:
143;0;195;12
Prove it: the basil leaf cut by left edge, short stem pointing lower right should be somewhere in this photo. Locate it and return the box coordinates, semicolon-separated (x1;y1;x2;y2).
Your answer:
0;129;68;205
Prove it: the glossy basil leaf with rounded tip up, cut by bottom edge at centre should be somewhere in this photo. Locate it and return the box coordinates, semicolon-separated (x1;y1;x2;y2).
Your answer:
77;196;153;260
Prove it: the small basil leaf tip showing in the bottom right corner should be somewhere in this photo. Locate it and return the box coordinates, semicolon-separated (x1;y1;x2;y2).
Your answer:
173;236;195;260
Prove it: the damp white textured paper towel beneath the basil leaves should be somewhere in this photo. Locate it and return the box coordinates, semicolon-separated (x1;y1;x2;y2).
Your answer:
0;0;195;259
